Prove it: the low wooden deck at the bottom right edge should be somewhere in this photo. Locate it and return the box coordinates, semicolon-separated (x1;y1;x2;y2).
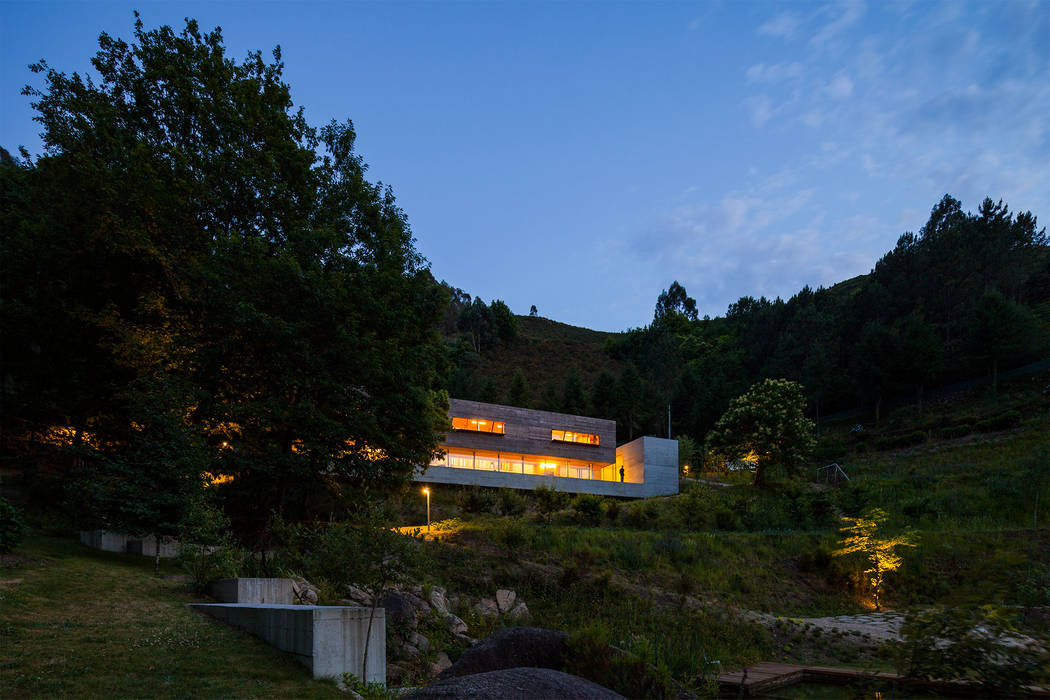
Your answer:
718;662;1050;698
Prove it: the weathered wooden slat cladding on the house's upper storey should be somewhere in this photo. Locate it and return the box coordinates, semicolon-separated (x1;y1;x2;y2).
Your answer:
442;399;616;464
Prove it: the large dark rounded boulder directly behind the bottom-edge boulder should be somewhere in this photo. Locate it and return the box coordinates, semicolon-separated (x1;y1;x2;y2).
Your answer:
441;628;569;680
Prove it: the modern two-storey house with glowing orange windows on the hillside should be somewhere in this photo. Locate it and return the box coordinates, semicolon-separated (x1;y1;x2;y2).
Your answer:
416;399;678;499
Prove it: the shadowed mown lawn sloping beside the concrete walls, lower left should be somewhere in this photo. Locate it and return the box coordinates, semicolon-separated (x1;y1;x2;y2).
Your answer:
0;537;343;699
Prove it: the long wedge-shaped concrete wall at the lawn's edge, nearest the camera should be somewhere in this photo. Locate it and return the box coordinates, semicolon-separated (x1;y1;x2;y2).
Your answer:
191;602;386;685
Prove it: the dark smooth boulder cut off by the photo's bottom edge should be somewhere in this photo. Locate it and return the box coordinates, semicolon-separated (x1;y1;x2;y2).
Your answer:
401;669;625;700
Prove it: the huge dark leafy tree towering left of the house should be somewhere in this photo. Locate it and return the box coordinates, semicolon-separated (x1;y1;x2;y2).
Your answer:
3;15;446;531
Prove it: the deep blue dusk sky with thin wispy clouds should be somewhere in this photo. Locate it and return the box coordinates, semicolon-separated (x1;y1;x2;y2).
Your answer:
0;0;1050;331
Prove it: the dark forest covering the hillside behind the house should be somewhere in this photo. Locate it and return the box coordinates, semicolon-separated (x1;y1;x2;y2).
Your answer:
444;195;1050;451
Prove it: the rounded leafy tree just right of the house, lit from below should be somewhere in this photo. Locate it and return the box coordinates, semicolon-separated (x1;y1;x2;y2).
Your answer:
707;379;814;486
